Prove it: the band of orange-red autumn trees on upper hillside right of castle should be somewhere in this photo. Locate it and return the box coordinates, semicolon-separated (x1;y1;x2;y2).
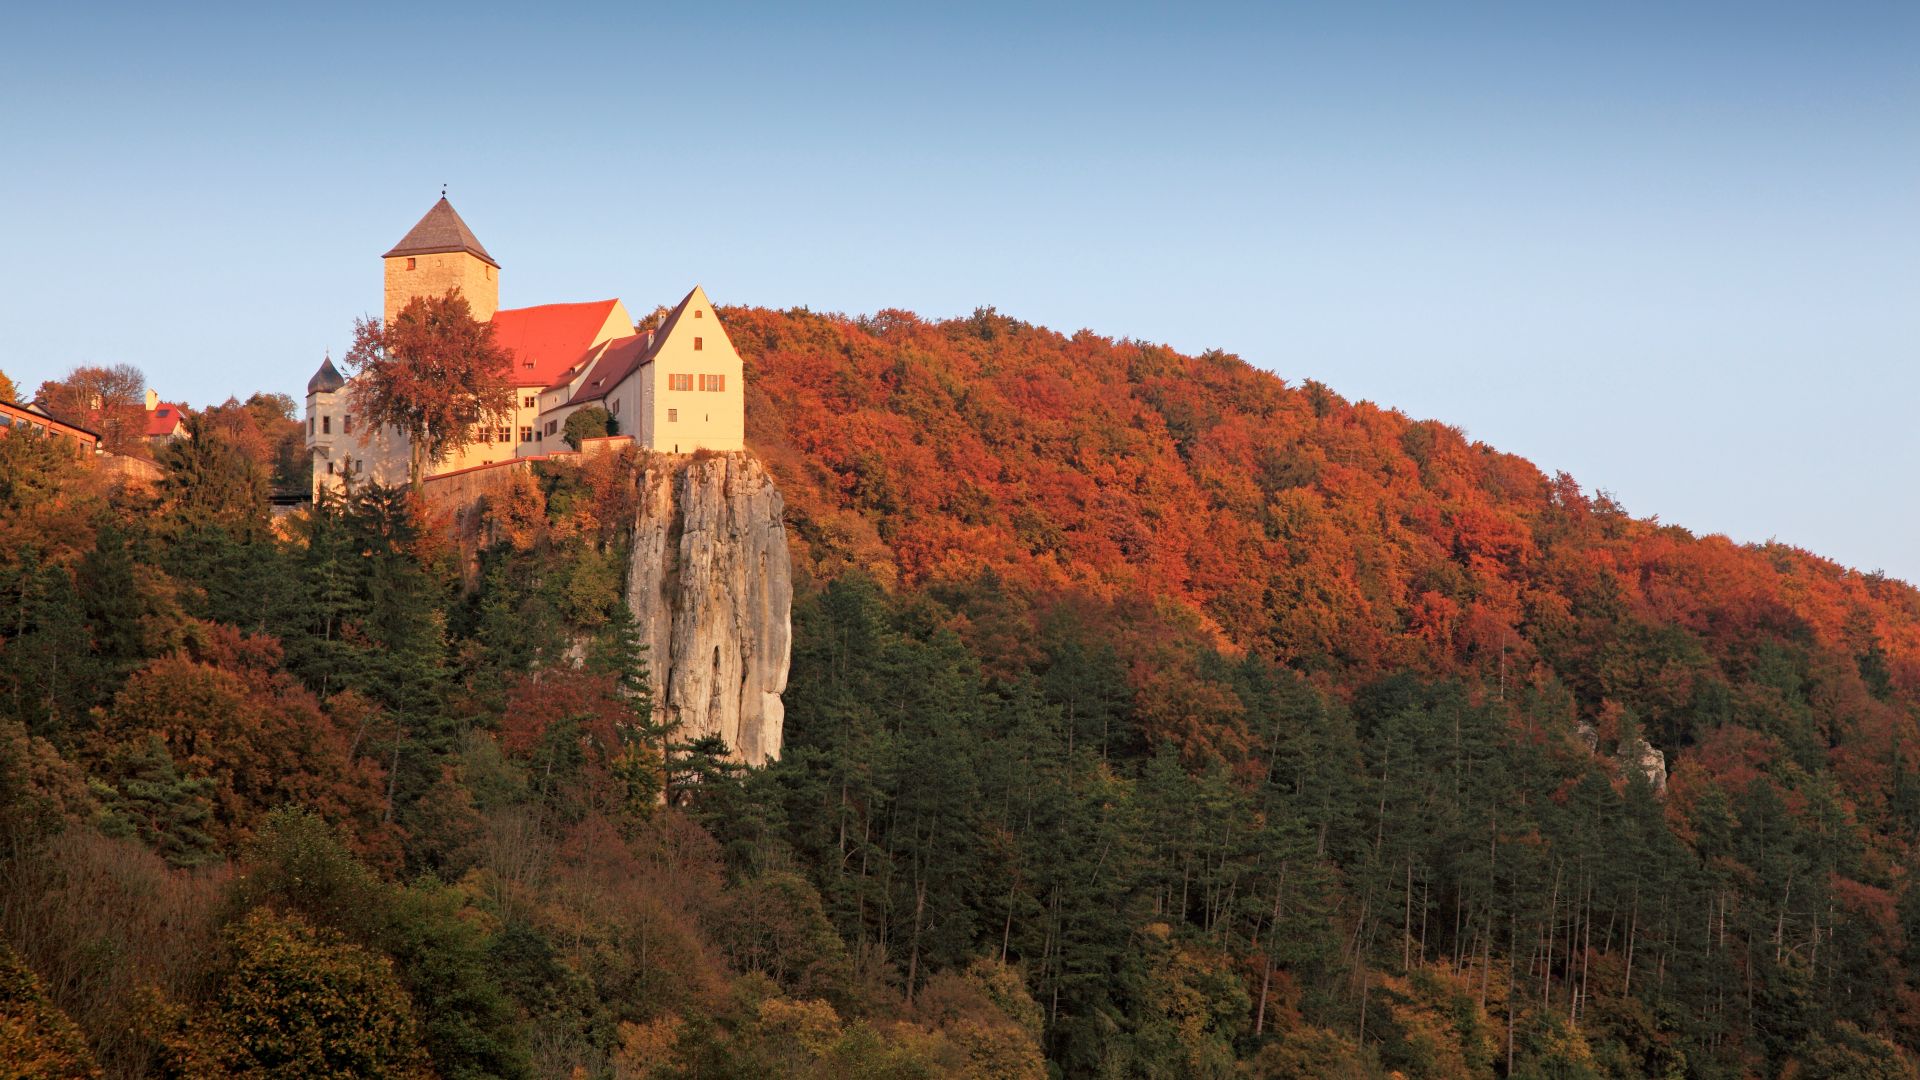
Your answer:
728;309;1920;734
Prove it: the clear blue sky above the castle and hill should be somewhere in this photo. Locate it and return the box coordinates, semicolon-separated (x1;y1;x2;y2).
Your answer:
0;0;1920;582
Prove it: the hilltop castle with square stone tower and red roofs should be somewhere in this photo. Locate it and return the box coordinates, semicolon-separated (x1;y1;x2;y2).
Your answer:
307;194;745;494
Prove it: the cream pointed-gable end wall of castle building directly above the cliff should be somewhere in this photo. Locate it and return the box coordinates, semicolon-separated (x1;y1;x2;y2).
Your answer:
637;286;747;454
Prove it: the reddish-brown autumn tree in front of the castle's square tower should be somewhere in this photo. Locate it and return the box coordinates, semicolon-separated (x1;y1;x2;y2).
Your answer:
346;288;513;490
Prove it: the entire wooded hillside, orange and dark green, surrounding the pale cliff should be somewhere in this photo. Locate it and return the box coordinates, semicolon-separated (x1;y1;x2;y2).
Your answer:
0;307;1920;1080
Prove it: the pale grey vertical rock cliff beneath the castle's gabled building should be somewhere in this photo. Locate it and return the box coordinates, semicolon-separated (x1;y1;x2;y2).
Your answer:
626;454;793;765
